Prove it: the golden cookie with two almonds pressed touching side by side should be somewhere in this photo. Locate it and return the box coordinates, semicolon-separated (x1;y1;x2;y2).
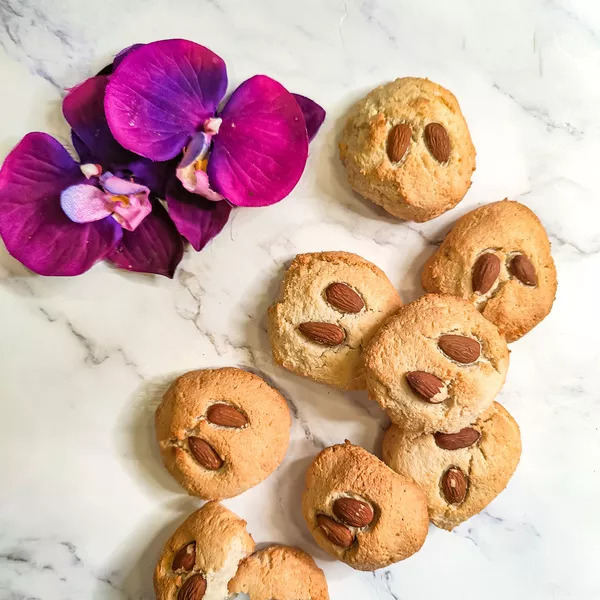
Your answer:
302;442;428;571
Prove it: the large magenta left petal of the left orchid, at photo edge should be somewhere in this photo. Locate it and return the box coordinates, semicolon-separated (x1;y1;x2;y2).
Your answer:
0;133;122;275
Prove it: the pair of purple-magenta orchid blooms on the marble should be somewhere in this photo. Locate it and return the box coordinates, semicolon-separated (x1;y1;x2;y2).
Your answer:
0;40;325;277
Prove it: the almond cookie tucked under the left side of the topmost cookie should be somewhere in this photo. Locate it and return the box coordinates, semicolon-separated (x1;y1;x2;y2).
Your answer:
268;252;402;390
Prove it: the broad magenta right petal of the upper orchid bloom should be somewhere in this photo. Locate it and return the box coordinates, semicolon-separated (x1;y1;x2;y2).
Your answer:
207;75;308;206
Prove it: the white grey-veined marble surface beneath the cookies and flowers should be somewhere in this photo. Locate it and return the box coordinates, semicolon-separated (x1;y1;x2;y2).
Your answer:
0;0;600;600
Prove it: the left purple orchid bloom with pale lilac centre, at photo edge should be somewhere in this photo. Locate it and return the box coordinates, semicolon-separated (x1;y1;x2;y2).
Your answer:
0;76;224;277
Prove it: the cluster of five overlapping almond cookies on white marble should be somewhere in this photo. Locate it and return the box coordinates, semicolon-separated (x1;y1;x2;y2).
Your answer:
268;200;556;570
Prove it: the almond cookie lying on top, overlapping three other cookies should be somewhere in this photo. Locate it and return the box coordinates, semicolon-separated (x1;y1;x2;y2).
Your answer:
365;294;508;432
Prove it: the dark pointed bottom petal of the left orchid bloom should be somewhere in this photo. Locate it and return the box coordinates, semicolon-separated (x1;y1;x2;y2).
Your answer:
107;202;183;278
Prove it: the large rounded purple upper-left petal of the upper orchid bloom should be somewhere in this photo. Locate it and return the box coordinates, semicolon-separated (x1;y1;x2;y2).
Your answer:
104;40;227;161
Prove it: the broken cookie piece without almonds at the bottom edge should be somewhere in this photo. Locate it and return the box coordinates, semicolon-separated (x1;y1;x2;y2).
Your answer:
229;546;329;600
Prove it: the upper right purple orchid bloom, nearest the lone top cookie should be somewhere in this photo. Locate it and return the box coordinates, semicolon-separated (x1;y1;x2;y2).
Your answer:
104;39;325;237
